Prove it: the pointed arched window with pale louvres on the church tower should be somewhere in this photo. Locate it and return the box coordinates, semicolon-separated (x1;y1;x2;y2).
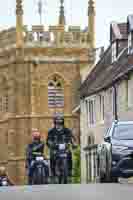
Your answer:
48;76;64;108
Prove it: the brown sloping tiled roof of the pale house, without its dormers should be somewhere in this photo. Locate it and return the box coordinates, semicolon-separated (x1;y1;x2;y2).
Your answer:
80;45;133;98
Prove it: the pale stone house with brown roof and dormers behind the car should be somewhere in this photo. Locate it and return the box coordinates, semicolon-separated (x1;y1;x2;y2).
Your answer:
80;15;133;182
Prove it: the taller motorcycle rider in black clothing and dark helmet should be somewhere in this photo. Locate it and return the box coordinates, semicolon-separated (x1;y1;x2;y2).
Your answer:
47;115;74;179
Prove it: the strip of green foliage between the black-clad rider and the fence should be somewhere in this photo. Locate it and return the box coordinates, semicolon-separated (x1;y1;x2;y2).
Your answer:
72;146;81;183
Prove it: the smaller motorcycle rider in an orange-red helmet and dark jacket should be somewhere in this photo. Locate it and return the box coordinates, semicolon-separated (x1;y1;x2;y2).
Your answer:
26;129;47;185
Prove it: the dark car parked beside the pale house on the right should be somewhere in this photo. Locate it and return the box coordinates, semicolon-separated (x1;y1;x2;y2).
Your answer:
97;121;133;182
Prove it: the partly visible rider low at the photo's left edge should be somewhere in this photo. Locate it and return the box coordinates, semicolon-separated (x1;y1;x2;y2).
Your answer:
0;166;14;186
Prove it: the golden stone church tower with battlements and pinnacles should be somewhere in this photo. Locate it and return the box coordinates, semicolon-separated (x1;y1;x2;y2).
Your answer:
0;0;95;184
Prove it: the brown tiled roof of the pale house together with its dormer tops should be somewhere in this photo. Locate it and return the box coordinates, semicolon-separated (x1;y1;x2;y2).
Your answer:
80;15;133;98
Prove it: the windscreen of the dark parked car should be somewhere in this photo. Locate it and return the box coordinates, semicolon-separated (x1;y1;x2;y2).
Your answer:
113;124;133;140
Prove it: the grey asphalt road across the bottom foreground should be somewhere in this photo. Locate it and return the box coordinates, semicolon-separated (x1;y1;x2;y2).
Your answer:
0;184;133;200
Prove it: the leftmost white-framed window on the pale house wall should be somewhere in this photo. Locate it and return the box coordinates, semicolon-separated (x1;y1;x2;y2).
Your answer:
87;99;96;125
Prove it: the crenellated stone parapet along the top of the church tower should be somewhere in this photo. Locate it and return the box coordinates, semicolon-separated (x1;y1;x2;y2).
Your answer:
0;25;89;48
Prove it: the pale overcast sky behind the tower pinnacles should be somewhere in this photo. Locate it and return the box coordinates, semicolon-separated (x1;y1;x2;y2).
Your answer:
0;0;133;46
